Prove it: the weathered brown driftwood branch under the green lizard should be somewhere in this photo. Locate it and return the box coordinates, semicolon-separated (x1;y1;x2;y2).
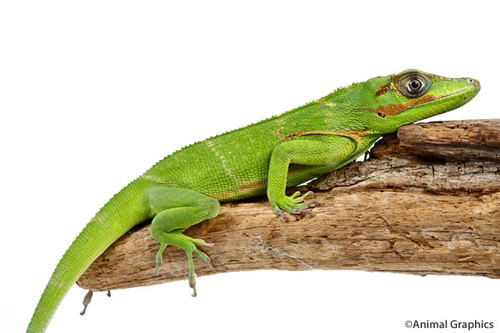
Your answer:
78;120;500;291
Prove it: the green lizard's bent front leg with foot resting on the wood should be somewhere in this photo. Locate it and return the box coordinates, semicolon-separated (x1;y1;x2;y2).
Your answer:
267;135;357;219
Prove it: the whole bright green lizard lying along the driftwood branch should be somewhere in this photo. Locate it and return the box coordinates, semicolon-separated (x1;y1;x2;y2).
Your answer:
28;70;480;332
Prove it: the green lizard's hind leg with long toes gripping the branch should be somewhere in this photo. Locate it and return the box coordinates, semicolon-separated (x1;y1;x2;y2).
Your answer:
148;187;219;296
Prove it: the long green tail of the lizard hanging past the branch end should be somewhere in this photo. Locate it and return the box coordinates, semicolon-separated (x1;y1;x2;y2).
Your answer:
27;179;148;333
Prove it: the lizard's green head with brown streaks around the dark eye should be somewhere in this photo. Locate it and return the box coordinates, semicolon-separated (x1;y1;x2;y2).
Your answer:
363;70;481;133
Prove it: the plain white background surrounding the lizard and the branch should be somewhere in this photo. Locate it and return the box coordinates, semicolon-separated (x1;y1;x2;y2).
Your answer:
0;0;500;332
